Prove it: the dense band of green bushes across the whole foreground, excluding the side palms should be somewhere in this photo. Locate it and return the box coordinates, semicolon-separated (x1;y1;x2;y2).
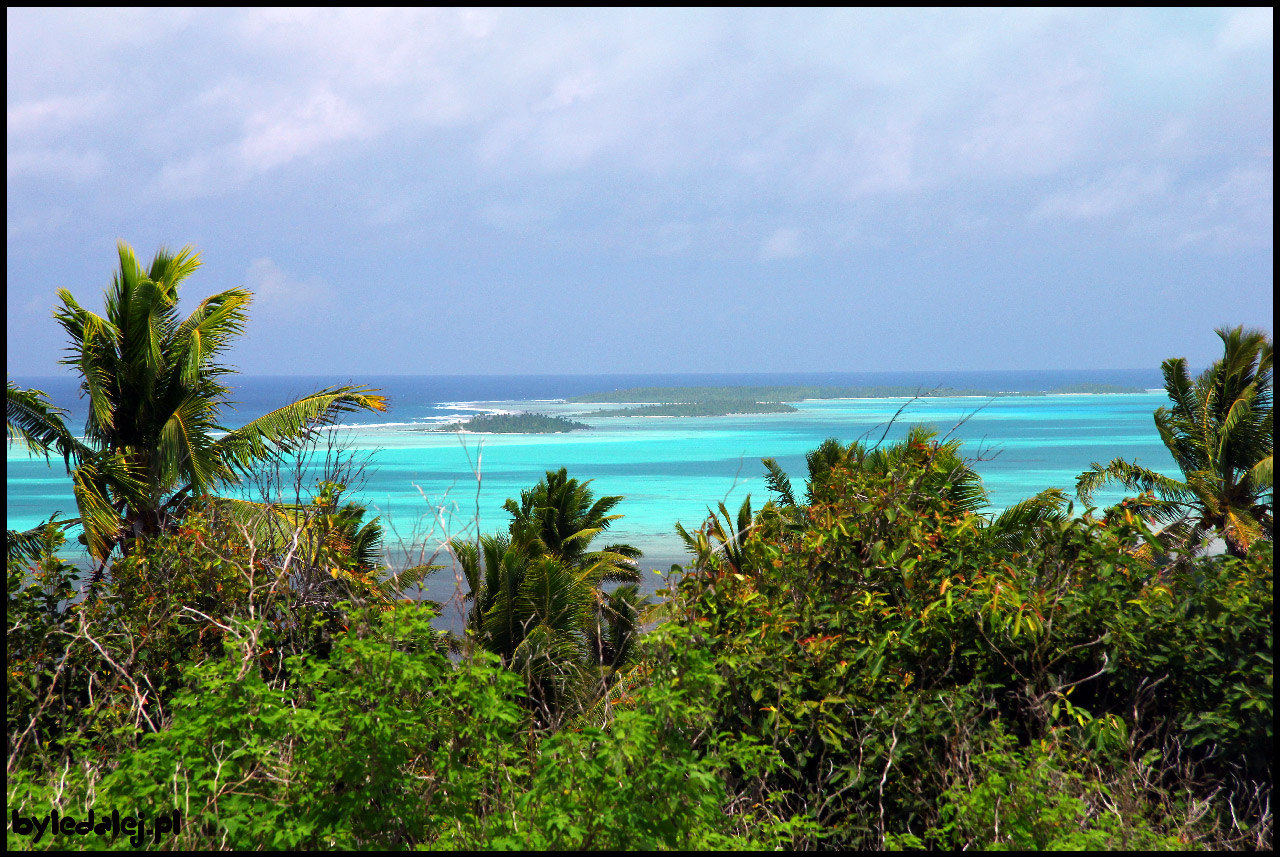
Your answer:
8;430;1274;848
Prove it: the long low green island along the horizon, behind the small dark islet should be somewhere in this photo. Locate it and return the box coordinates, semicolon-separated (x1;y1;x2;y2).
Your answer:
568;384;1146;417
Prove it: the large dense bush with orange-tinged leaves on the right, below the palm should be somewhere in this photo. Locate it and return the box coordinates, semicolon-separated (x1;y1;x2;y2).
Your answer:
672;435;1272;847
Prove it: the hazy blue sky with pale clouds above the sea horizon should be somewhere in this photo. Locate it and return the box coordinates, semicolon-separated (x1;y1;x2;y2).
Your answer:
6;9;1274;375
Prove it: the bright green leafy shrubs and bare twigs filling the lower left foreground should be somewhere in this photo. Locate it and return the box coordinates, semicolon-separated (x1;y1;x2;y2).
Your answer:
8;511;787;849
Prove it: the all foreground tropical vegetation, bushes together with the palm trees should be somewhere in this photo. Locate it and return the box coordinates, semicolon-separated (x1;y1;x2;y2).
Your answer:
6;246;1275;851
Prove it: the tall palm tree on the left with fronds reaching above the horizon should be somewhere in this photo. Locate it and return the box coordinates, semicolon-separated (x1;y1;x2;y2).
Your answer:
6;242;387;579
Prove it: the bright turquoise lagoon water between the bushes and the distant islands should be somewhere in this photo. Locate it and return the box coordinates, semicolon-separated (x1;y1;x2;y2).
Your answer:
6;376;1178;583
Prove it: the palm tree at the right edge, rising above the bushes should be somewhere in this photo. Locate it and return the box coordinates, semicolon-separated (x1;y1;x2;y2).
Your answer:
1075;326;1275;556
